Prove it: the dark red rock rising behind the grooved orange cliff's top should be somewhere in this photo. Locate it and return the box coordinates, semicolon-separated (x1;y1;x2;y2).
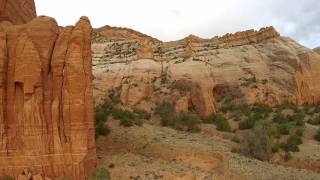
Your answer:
0;0;37;24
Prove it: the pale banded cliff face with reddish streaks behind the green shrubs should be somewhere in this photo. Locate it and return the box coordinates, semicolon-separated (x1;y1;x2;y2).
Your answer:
92;27;320;115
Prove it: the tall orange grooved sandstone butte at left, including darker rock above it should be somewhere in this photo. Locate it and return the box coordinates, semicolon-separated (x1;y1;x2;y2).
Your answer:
0;0;96;180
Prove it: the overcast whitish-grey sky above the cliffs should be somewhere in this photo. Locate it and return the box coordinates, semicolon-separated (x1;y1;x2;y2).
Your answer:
35;0;320;48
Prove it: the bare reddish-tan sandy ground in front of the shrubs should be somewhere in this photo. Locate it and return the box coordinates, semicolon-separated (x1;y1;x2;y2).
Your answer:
97;120;320;180
